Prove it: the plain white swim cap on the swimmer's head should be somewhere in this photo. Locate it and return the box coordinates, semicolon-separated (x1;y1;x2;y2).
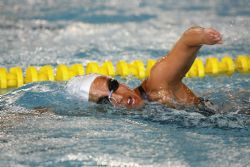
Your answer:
66;74;101;101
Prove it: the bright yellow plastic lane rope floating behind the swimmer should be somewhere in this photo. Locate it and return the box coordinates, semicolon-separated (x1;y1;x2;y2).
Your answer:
0;55;250;89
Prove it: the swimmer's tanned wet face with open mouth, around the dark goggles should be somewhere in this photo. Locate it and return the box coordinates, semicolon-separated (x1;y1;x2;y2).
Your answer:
90;76;144;108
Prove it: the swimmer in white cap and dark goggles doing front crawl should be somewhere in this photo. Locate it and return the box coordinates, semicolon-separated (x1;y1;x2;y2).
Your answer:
67;27;222;113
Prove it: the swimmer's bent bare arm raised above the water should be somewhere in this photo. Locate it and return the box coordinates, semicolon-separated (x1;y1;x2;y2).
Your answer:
146;27;222;90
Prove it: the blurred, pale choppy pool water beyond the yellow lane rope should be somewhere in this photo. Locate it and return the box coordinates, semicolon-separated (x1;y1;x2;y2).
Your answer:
0;1;250;67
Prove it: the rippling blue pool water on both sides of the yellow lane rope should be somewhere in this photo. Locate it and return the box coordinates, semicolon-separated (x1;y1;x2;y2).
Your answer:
0;0;250;167
